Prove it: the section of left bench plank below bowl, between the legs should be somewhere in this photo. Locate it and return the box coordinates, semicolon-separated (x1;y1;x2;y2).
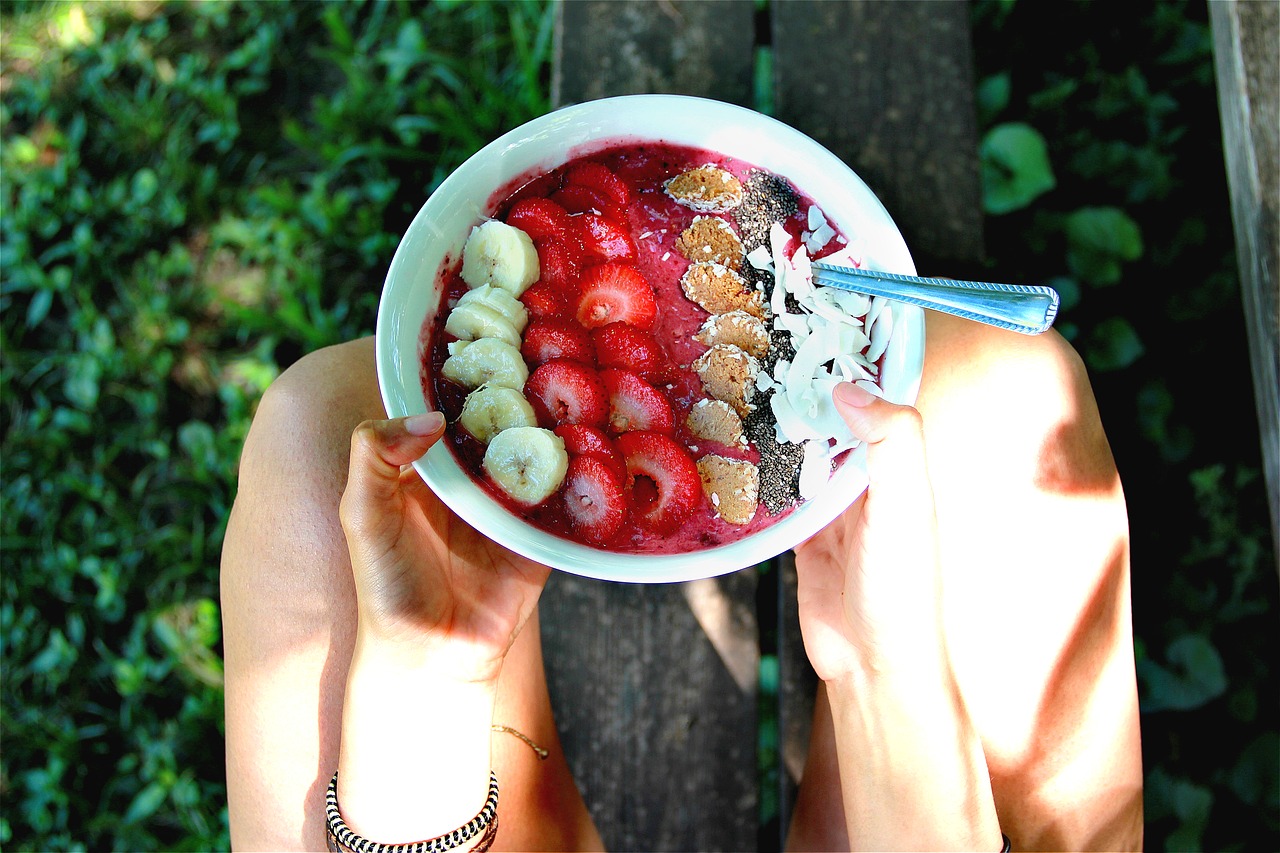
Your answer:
540;570;759;850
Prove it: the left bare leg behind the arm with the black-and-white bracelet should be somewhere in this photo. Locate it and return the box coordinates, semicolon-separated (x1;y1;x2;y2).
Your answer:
221;339;602;850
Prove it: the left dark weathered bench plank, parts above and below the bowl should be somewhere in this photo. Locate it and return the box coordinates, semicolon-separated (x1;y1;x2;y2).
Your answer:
540;0;759;850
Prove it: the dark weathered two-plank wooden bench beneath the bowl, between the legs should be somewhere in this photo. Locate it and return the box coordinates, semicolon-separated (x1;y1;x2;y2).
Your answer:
541;0;983;850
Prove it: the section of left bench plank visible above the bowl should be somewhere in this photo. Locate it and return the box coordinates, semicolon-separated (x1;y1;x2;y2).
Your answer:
552;0;755;106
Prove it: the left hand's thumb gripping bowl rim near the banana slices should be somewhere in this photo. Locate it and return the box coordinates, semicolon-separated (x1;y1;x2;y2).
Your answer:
344;411;444;512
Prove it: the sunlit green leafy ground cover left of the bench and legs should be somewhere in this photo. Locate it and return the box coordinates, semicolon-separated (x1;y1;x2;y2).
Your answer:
0;3;550;850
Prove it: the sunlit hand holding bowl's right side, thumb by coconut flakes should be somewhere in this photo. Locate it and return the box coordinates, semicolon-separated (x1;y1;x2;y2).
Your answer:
796;383;945;681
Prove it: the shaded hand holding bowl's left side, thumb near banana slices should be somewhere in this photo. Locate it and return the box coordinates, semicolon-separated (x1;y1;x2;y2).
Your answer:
340;412;550;684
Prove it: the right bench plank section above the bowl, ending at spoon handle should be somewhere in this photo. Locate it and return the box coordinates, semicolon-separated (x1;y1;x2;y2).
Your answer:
771;0;983;275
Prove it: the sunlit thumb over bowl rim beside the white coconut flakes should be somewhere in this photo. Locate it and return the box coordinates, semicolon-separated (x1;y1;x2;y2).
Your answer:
832;382;933;501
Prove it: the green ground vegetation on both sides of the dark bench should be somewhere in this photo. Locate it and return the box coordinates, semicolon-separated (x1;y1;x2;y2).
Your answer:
0;0;1280;849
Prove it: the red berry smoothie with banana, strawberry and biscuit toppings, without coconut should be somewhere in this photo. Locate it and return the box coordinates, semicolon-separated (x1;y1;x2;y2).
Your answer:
421;141;876;555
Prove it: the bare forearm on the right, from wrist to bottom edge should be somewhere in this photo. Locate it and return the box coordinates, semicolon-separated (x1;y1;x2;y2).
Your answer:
827;663;1001;850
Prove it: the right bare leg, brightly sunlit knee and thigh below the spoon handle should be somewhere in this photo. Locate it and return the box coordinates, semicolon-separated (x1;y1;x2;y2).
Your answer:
788;313;1142;850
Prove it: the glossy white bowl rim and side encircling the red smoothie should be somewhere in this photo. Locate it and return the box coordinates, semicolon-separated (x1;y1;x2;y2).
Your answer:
375;95;924;583
